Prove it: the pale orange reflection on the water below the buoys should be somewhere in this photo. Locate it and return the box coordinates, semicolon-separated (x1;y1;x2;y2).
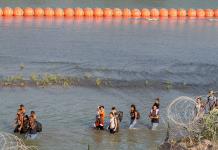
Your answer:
0;17;218;31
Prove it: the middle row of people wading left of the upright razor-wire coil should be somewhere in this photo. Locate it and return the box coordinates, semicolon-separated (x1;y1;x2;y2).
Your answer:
94;97;160;134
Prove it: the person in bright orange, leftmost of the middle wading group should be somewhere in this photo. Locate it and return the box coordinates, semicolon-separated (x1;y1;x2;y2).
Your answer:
95;106;105;130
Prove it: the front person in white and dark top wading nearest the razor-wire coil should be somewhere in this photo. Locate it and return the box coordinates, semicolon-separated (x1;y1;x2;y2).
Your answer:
149;105;160;130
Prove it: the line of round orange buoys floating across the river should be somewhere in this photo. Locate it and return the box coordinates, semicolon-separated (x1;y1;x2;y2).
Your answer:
0;7;218;18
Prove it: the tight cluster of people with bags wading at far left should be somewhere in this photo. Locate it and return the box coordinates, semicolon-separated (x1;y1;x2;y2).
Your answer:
14;104;42;139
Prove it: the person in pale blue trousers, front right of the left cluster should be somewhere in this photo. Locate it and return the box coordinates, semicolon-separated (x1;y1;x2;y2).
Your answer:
26;116;37;139
